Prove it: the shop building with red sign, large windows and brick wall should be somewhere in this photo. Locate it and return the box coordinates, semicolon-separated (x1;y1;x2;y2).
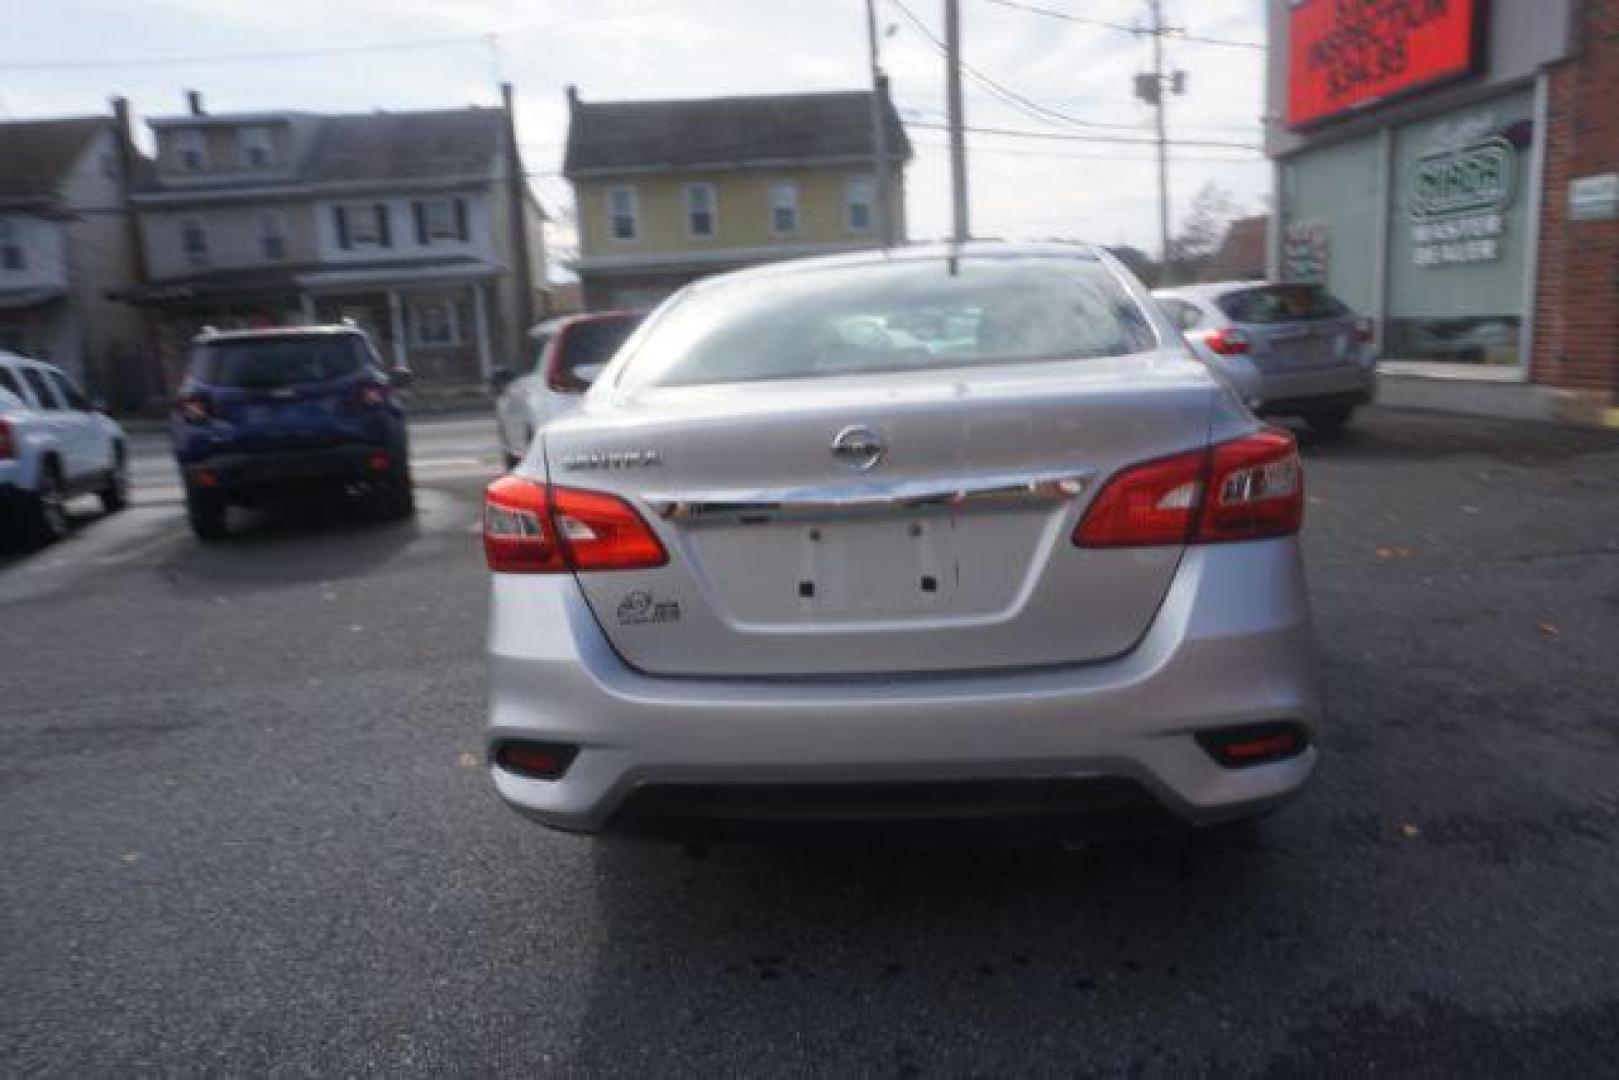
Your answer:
1266;0;1619;424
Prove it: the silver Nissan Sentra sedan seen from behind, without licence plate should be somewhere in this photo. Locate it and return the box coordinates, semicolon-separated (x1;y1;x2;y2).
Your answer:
484;243;1318;832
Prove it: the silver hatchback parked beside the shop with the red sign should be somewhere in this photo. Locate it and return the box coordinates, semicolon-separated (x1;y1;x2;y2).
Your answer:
1153;282;1378;432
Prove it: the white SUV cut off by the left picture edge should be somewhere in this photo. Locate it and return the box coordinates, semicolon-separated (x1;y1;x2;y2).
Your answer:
0;351;130;544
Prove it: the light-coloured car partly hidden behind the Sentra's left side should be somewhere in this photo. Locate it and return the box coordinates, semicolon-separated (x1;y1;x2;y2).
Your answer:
494;311;646;468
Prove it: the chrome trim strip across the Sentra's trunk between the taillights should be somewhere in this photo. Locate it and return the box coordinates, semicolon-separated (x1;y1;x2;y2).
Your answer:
641;470;1096;525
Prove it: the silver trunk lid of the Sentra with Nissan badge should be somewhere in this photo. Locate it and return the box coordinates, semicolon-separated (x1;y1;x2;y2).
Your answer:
544;353;1216;677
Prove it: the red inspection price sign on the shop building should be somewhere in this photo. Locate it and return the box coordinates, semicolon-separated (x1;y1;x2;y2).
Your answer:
1287;0;1480;128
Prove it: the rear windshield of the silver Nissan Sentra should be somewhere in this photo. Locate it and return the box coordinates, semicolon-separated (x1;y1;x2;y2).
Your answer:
620;256;1158;387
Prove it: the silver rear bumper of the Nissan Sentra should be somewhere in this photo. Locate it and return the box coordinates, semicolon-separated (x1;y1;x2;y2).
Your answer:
489;539;1319;832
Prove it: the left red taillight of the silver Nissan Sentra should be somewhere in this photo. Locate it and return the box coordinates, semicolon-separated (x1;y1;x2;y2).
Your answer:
484;476;669;573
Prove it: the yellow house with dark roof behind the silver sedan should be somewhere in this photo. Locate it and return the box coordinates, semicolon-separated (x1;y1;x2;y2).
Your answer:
563;87;911;309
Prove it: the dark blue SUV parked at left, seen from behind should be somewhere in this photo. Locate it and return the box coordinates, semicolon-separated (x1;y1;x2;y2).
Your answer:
170;324;414;541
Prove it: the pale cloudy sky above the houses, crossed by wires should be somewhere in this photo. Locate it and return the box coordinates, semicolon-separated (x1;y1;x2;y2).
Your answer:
0;0;1271;278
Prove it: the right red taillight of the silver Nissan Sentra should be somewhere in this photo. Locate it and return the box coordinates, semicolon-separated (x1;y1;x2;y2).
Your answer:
1073;427;1305;547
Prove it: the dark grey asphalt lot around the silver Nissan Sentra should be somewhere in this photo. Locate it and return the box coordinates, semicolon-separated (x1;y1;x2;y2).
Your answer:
0;411;1619;1077
